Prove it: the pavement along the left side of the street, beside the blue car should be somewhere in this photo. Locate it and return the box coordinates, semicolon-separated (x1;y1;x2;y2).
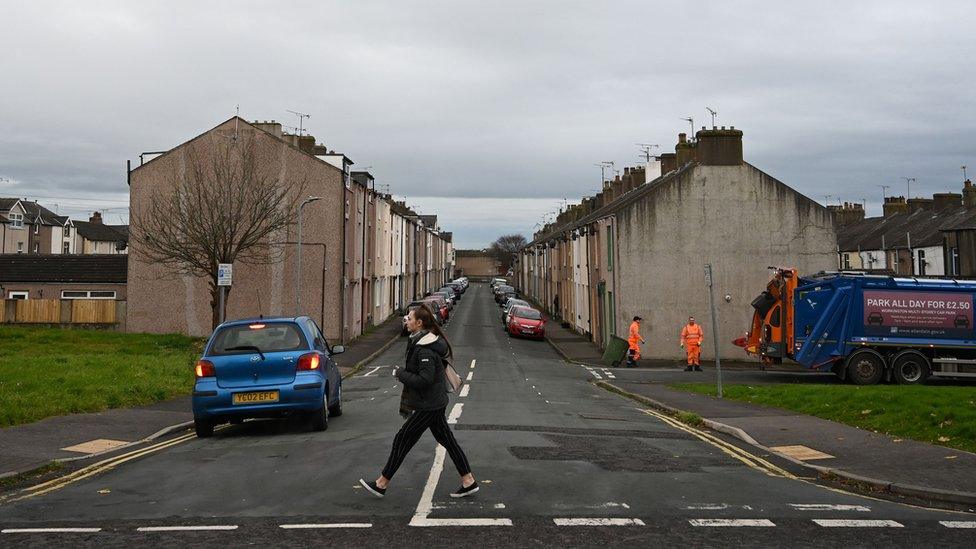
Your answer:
0;316;401;479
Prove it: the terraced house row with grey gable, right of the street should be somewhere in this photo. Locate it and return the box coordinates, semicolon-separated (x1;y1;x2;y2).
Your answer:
517;127;837;359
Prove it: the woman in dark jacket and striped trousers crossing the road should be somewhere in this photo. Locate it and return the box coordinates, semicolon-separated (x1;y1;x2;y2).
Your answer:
359;307;478;498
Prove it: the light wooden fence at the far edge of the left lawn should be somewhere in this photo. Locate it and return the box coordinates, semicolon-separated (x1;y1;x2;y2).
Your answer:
0;299;125;324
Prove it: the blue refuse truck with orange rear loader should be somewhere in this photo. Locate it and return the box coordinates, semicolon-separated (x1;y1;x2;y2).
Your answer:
735;267;976;385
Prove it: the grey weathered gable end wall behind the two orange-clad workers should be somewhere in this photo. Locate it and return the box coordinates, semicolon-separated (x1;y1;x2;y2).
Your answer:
616;164;836;360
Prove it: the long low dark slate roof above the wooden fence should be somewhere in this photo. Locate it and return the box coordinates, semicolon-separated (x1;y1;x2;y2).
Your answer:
0;254;129;284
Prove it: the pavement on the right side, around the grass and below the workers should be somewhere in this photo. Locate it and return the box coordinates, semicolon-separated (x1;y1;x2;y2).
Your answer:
547;318;976;505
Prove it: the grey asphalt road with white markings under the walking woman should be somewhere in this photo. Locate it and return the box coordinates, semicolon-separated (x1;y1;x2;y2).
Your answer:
0;285;976;547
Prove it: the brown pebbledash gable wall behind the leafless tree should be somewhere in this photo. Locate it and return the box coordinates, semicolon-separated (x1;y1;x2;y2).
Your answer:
126;118;345;341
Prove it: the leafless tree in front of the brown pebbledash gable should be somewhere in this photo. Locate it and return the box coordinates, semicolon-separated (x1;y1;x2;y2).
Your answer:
131;132;305;328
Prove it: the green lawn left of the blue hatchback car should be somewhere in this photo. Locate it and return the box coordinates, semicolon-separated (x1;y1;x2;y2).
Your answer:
0;326;203;427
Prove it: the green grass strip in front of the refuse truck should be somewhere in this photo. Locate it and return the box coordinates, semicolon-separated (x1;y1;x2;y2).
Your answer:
671;383;976;452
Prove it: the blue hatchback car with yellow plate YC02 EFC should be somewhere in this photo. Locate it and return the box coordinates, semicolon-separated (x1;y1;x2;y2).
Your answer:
193;316;343;437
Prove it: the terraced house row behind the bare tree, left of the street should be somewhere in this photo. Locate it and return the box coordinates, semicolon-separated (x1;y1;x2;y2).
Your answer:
127;117;454;342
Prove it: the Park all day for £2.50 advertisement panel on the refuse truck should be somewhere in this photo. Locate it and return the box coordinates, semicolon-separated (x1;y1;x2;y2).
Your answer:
864;291;973;338
